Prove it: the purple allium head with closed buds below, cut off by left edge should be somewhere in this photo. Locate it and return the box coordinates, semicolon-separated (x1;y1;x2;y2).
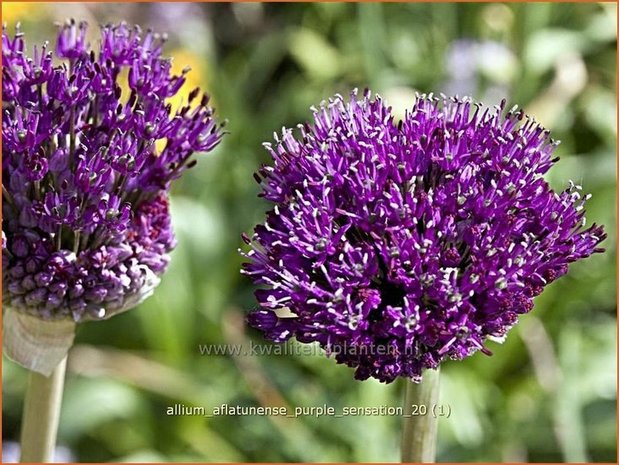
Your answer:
2;21;221;322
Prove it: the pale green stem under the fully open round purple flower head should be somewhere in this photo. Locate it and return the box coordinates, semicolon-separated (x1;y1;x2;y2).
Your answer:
402;369;439;463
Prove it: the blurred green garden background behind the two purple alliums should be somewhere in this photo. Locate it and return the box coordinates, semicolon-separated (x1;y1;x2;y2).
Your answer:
2;2;617;462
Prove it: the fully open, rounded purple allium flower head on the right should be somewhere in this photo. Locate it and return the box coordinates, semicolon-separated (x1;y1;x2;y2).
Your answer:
243;92;605;382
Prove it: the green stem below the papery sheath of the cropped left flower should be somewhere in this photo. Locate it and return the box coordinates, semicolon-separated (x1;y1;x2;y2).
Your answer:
20;357;67;463
